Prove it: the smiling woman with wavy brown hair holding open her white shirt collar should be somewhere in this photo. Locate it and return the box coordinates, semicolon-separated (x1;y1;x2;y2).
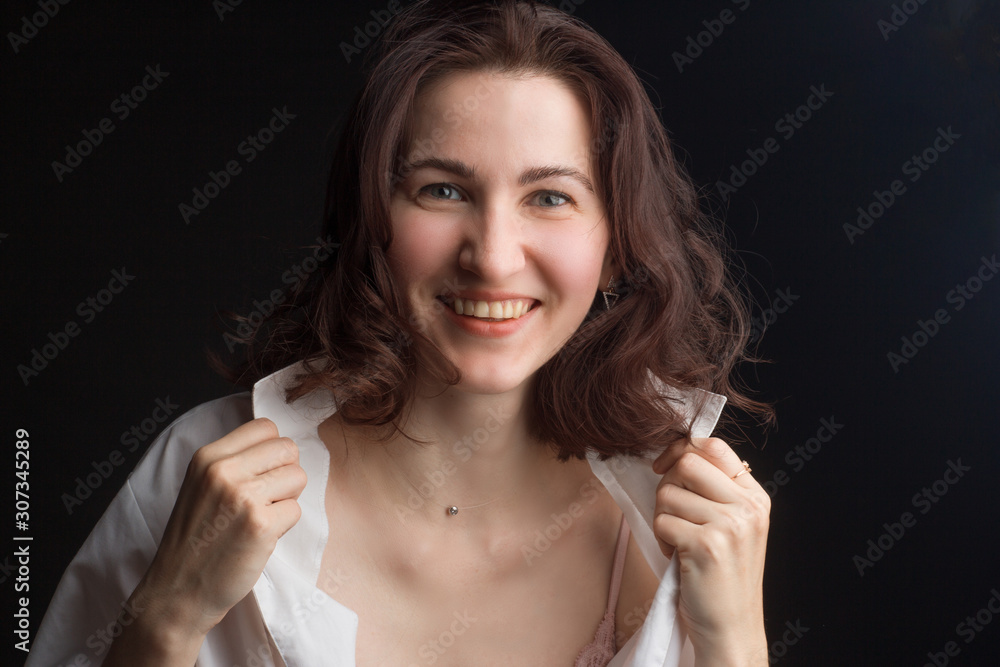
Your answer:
29;1;769;667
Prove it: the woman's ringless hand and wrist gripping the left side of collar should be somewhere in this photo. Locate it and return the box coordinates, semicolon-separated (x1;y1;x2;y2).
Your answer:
108;419;306;664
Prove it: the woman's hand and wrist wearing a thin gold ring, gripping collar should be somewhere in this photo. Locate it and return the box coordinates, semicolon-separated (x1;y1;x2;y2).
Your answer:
653;438;771;665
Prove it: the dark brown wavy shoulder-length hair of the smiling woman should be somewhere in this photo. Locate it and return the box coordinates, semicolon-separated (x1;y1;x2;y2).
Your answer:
214;0;774;460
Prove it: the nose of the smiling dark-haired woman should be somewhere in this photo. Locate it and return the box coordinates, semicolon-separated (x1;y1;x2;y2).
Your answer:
459;205;525;284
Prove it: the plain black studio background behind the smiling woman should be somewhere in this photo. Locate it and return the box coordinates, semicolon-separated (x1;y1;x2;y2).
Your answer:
0;0;1000;665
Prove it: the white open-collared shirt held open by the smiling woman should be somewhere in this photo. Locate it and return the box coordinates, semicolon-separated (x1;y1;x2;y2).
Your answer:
26;364;726;667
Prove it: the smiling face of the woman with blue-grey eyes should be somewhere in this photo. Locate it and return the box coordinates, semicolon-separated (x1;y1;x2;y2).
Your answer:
389;72;611;393
